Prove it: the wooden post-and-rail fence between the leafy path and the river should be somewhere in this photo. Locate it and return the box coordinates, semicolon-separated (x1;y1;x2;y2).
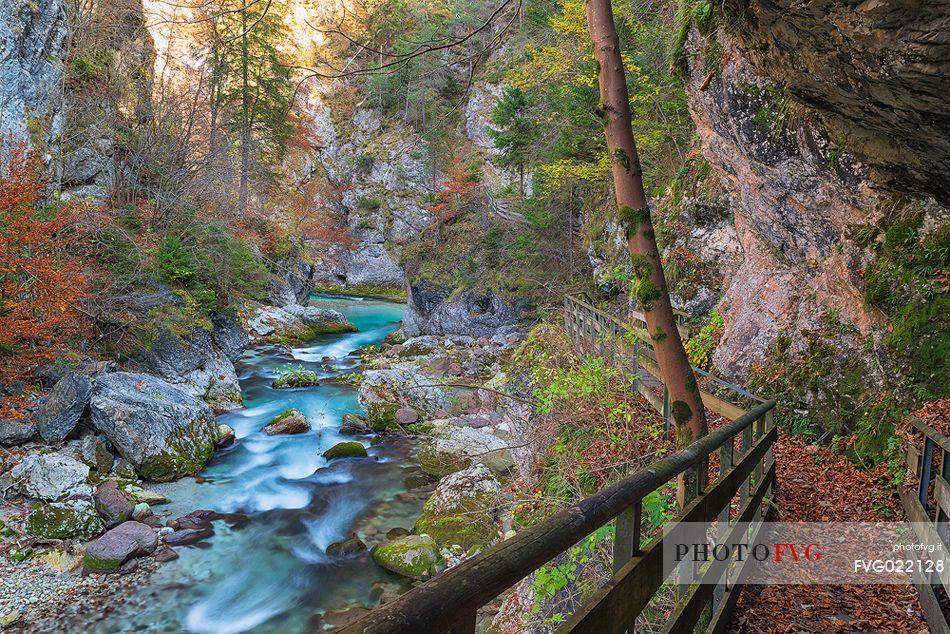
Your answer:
343;296;778;634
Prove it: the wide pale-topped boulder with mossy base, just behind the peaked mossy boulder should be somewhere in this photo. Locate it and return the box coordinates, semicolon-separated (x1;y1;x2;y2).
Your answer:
419;426;514;477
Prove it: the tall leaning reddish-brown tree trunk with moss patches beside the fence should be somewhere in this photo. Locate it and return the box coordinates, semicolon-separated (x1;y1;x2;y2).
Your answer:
587;0;706;497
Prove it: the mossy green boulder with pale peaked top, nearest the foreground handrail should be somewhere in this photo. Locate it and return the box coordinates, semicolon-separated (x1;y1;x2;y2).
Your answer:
415;464;501;550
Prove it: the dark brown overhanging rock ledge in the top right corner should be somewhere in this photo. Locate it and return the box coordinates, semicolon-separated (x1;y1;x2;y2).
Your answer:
725;0;950;205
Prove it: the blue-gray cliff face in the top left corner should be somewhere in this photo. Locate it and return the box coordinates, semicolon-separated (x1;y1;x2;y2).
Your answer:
0;0;68;142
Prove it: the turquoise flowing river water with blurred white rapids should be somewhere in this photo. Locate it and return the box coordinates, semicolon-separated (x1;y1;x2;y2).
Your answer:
91;296;425;634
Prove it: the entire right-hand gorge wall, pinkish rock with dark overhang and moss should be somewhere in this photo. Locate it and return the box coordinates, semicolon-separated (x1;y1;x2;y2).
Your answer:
674;1;950;434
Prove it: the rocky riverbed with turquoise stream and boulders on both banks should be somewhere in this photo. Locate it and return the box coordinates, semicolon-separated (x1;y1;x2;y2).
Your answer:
0;292;540;632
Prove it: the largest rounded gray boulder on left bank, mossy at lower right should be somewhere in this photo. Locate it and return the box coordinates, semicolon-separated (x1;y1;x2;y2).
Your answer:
90;372;218;482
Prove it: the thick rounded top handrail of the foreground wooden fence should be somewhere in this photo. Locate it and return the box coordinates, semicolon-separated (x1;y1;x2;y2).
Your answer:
342;401;775;634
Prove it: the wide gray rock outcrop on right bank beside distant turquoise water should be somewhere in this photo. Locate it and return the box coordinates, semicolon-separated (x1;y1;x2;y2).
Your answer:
402;280;527;337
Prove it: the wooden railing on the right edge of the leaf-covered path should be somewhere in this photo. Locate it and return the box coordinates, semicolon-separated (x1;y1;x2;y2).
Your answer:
901;416;950;632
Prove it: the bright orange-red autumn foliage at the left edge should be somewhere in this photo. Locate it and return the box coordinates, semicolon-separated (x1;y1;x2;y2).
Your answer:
0;145;89;378
